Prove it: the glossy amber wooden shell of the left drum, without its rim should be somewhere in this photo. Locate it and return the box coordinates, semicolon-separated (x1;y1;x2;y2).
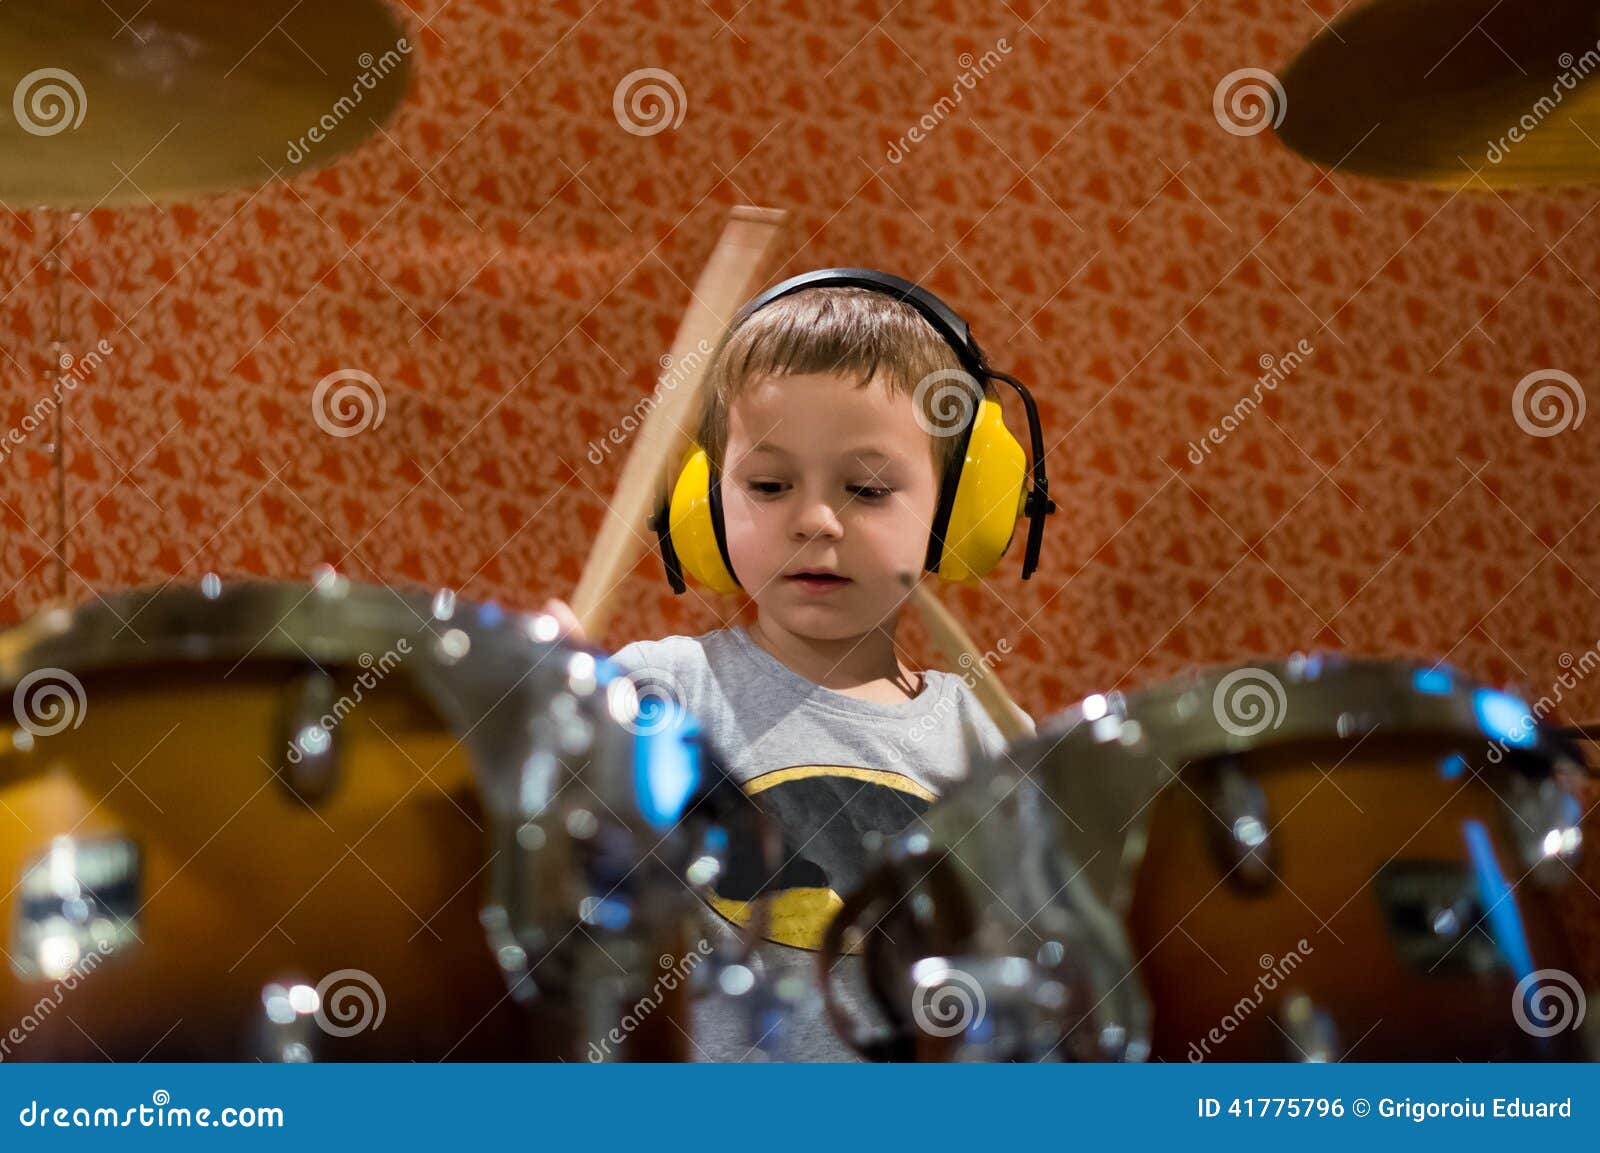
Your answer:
0;660;554;1060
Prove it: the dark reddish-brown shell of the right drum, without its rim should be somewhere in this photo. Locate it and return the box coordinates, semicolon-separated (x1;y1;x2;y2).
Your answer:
1128;734;1582;1060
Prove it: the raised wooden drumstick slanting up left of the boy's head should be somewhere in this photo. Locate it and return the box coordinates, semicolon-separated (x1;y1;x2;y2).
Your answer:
571;205;787;643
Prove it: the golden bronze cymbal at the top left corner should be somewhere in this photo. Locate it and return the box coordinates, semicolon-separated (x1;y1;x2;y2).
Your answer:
0;0;414;209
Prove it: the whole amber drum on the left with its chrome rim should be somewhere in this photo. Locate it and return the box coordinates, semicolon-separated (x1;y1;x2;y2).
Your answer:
0;571;729;1060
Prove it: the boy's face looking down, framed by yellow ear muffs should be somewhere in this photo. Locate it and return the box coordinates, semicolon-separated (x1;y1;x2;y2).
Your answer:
722;374;938;640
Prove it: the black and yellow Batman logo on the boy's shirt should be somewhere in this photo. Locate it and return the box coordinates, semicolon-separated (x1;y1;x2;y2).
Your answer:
710;764;936;950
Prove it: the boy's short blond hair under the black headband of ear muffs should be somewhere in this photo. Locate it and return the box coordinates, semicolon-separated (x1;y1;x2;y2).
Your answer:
696;288;989;483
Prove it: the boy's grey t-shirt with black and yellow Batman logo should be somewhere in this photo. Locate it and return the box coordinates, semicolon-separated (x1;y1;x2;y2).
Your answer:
613;627;1005;1060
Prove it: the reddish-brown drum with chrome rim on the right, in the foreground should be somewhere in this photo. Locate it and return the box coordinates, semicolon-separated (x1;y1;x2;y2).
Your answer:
842;656;1586;1062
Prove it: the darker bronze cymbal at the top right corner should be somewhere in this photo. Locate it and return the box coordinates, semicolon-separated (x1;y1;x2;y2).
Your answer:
1278;0;1600;187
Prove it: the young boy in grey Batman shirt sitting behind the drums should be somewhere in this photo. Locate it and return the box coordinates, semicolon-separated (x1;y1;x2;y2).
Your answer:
546;278;1030;1060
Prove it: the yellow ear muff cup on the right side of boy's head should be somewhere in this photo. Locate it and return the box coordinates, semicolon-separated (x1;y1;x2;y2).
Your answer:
934;398;1027;584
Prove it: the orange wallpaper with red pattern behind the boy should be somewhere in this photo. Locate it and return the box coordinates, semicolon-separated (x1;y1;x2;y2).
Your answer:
0;0;1600;738
